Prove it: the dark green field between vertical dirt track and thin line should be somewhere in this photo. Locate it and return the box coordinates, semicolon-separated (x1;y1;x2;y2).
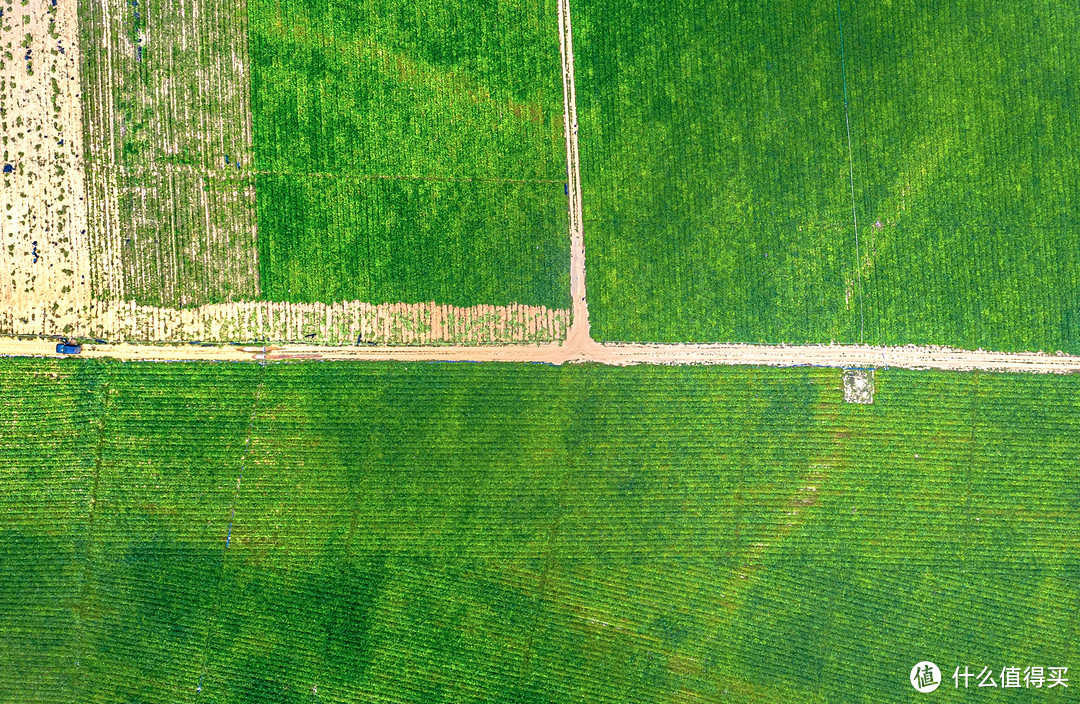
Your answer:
572;0;859;342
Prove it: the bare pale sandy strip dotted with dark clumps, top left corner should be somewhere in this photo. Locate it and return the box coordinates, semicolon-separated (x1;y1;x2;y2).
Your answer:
0;2;90;335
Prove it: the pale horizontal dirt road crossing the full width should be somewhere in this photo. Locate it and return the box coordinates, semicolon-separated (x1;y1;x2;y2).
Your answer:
0;337;1080;374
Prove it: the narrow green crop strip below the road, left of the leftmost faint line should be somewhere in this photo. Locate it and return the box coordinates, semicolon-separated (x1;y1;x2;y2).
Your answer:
0;363;105;702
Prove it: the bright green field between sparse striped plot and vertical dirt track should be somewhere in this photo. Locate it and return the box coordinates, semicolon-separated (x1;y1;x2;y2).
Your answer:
247;0;569;308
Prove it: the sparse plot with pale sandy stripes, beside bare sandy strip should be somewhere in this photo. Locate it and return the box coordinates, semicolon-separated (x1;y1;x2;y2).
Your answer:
80;0;259;308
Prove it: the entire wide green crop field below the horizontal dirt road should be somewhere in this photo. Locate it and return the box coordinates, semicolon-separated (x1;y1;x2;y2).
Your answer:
0;361;1080;703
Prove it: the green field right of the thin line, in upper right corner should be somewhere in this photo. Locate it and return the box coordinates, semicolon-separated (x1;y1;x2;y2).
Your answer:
842;0;1080;353
